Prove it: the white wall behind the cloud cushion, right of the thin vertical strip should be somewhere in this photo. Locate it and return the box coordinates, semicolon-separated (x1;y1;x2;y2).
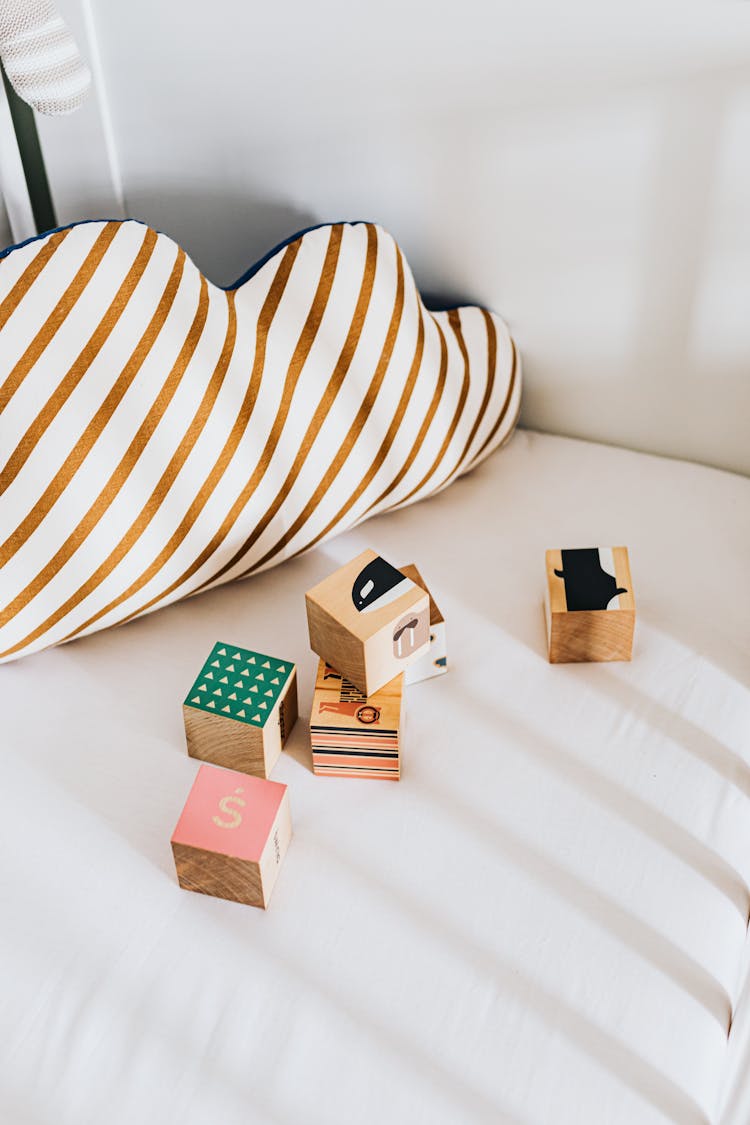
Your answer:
45;0;750;473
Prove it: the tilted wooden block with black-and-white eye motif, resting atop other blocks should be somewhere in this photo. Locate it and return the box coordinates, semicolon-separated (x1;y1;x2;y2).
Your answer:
305;550;430;695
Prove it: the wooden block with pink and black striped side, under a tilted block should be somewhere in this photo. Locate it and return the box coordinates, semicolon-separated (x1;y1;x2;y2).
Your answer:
310;660;404;781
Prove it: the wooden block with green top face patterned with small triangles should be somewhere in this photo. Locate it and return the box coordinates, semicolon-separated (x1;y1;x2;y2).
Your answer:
182;641;297;777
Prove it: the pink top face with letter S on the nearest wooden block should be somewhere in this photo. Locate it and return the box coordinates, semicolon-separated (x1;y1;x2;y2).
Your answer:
172;765;287;862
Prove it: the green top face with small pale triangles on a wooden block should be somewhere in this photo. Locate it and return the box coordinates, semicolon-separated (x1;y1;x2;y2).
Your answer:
184;641;295;727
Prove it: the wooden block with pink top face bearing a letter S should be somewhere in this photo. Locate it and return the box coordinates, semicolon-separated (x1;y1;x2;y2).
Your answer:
172;760;291;909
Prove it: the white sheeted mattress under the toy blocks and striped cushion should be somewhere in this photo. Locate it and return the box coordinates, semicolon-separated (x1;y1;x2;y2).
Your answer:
0;431;750;1125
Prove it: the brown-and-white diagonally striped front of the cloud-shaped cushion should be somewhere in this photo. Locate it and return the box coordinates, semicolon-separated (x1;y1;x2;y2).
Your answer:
0;221;521;662
